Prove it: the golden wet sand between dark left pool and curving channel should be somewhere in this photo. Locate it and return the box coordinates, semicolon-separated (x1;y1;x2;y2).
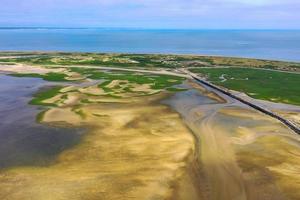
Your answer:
0;80;199;200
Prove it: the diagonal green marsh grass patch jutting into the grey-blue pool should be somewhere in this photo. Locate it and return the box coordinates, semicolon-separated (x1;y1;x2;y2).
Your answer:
29;86;62;106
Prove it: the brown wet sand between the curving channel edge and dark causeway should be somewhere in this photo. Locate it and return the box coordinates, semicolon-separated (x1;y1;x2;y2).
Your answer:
165;80;300;200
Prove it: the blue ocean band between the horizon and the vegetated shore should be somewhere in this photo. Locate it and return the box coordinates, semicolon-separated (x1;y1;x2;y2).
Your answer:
0;28;300;61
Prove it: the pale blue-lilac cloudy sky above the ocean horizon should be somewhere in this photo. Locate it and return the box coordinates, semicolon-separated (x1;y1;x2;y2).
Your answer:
0;0;300;29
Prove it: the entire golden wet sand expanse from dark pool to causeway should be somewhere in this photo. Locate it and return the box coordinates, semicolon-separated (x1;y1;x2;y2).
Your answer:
0;74;300;200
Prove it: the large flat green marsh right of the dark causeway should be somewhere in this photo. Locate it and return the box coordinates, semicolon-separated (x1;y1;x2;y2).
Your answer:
191;68;300;105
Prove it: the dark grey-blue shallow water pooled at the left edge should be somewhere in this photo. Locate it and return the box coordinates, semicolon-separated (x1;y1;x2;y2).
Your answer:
0;75;82;168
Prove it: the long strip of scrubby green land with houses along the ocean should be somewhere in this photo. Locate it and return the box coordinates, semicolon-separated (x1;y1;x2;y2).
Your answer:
0;52;300;71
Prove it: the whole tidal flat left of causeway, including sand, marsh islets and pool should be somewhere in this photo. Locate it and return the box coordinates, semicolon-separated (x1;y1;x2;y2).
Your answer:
0;52;300;200
